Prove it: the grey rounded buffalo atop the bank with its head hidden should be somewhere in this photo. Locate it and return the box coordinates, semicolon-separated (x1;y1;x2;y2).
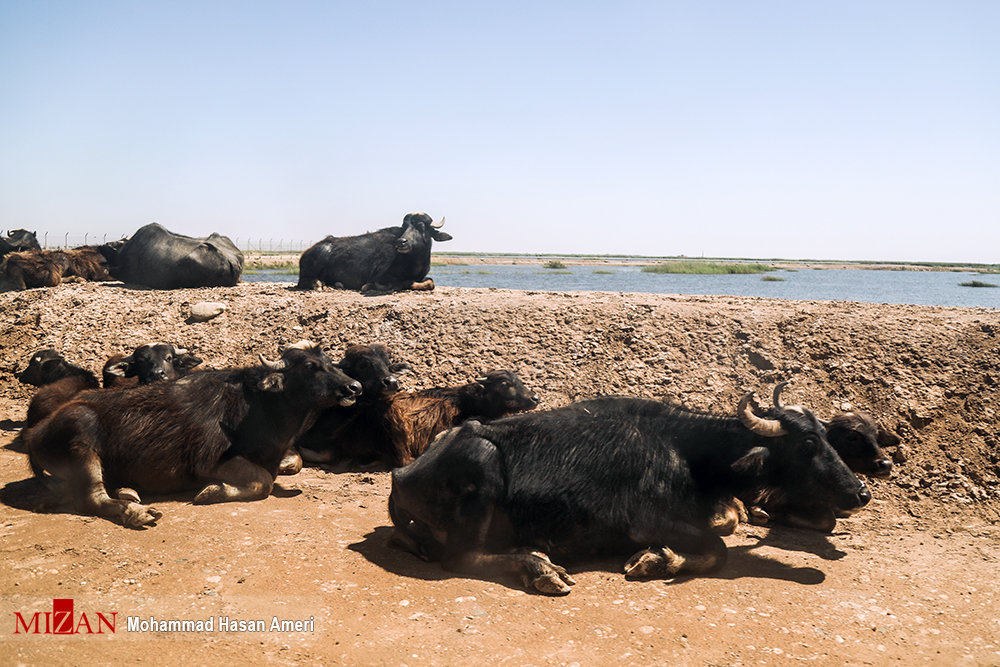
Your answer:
114;222;243;289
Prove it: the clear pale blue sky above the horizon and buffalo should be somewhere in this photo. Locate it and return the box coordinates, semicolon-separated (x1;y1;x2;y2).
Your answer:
0;0;1000;263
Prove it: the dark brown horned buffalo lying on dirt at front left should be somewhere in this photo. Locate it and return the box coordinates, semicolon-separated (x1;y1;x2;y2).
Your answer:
23;341;361;528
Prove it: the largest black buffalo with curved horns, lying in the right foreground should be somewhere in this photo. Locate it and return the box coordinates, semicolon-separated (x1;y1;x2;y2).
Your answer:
389;386;871;595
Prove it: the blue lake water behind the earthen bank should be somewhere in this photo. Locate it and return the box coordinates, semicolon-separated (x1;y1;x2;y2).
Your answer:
243;264;1000;308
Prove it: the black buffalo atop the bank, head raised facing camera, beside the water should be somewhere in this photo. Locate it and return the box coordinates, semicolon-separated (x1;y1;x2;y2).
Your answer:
298;213;451;291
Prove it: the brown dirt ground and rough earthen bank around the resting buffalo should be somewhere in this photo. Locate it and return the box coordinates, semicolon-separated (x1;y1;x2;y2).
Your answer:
0;284;1000;665
